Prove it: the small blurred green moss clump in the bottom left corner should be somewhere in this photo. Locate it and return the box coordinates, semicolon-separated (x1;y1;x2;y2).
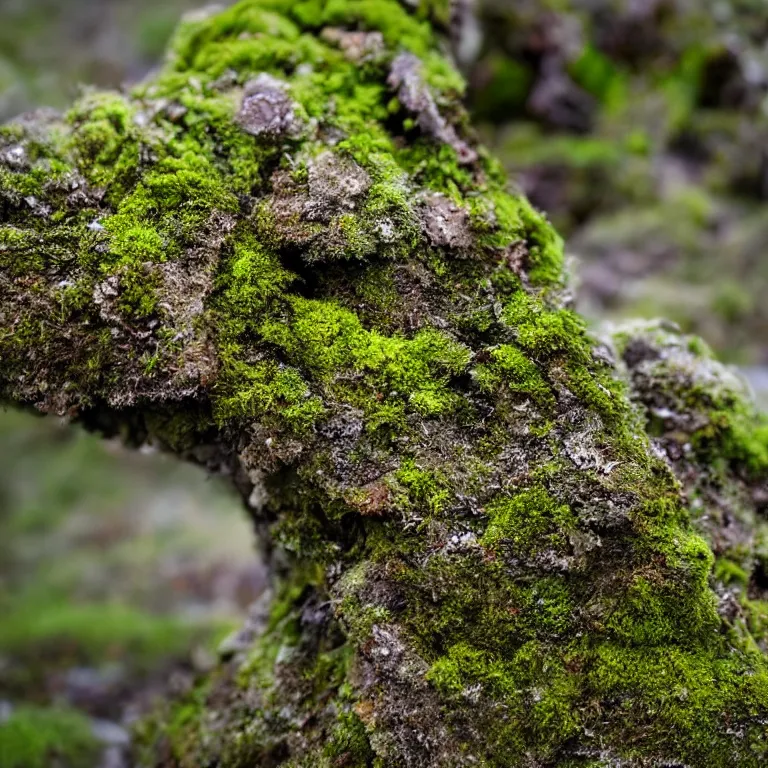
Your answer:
0;706;98;768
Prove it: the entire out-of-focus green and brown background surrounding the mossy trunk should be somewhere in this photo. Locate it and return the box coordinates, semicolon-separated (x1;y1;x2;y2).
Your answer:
0;0;768;768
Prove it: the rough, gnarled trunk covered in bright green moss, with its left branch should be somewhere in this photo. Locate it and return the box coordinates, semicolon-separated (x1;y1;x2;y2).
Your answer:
0;0;768;768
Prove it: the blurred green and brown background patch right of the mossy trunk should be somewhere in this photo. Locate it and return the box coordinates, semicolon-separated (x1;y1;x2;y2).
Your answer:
470;0;768;390
